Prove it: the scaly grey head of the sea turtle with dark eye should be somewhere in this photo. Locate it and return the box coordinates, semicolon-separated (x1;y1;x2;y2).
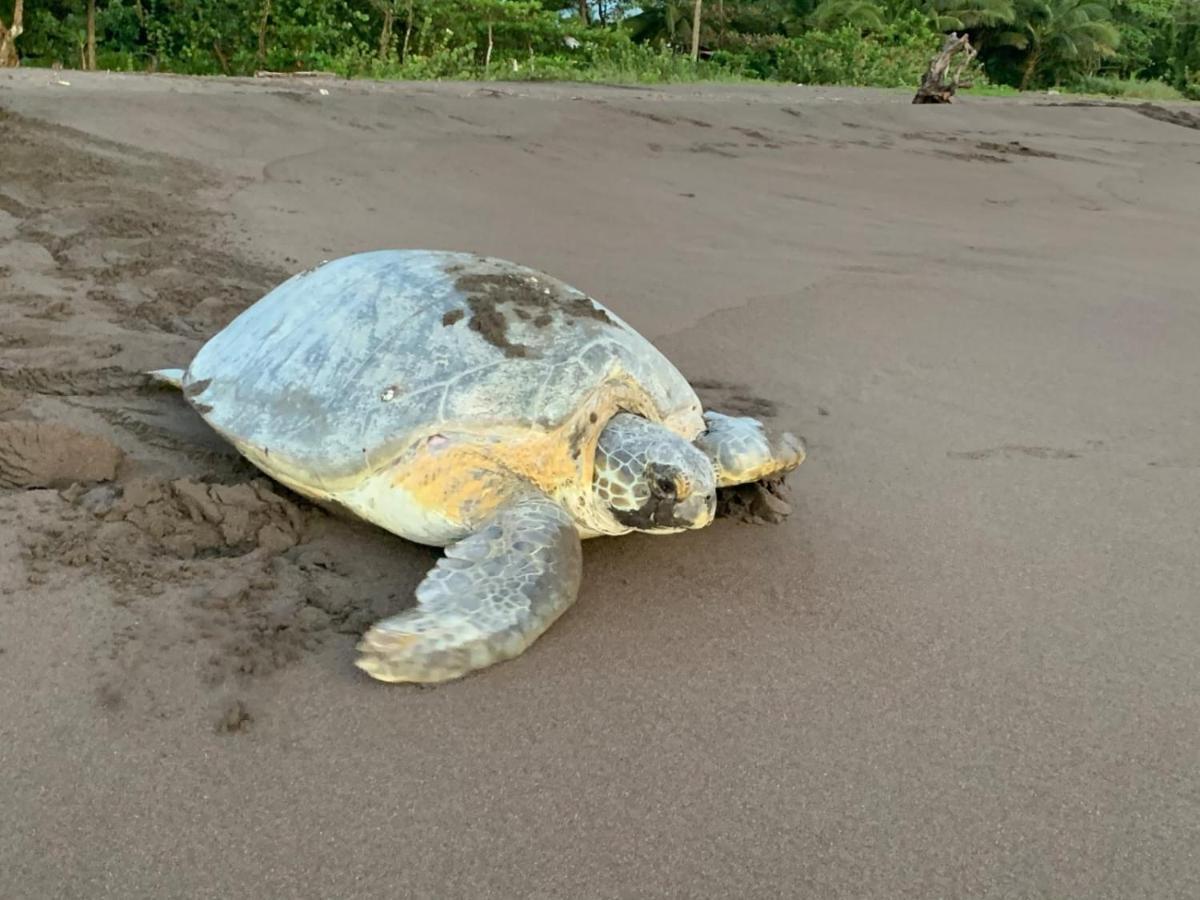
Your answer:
593;413;716;533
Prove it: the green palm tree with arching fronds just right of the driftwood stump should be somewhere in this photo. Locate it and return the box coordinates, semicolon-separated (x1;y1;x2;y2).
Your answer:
992;0;1121;90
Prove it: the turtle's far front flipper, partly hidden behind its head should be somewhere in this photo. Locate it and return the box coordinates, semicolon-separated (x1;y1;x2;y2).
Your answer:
695;412;806;487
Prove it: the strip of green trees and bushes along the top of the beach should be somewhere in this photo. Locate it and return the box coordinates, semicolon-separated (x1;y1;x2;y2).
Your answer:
0;0;1200;100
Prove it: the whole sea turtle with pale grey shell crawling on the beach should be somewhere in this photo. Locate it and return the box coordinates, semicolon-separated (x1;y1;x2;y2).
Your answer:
151;250;805;683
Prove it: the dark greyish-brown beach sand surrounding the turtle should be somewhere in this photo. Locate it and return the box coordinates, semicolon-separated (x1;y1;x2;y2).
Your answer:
0;71;1200;900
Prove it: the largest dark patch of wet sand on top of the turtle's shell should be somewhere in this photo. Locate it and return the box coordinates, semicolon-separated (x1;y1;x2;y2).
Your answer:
443;274;617;356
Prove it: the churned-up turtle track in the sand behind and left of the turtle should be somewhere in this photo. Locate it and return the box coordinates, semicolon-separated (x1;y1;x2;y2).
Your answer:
0;103;403;733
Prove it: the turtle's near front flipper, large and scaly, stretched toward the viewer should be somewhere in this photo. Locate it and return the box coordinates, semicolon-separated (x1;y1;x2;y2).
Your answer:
355;493;583;683
